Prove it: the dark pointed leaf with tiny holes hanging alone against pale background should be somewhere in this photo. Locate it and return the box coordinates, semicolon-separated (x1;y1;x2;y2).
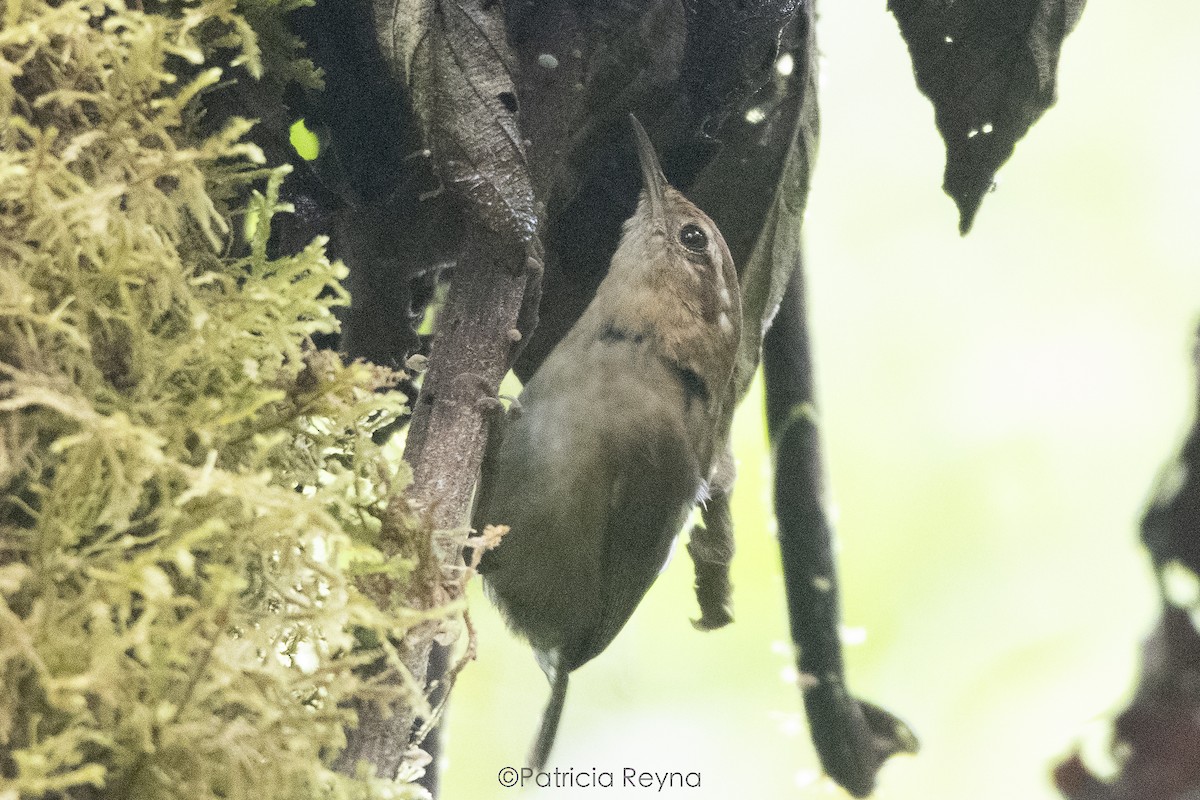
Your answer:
888;0;1085;234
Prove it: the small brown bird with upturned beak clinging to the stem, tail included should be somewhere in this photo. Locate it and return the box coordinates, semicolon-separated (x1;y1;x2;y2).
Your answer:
475;118;742;770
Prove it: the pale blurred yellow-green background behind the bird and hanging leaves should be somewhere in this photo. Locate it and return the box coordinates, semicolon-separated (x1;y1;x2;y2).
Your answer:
445;0;1200;800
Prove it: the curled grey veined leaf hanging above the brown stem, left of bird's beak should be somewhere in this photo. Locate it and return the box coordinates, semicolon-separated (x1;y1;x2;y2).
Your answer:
405;0;538;243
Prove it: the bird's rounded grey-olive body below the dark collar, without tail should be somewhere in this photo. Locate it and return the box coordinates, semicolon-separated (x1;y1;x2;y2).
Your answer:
476;344;700;674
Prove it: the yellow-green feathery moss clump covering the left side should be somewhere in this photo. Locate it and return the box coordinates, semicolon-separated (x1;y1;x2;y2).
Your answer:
0;0;441;800
